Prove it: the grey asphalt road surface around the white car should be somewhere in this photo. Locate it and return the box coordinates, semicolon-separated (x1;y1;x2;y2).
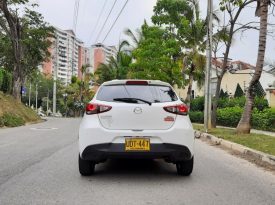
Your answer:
0;119;275;205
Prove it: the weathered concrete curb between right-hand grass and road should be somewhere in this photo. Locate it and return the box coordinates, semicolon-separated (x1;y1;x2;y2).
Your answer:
195;131;275;166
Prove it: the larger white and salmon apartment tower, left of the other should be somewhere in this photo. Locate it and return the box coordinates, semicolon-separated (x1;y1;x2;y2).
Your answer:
42;28;87;85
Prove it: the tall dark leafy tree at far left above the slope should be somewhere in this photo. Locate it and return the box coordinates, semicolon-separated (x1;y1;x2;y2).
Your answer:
0;0;52;100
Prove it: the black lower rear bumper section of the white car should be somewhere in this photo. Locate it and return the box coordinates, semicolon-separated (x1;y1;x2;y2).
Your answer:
81;143;192;162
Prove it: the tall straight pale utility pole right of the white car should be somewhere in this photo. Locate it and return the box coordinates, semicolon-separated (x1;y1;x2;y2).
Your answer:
204;0;213;132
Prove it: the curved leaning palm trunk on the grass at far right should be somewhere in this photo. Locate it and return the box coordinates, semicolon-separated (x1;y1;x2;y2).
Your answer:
237;0;269;134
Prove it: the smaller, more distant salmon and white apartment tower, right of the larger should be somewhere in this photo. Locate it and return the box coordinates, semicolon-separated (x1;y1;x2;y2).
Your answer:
90;43;117;73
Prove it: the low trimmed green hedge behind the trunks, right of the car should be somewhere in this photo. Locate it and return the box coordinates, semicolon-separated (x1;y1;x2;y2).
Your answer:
189;106;275;131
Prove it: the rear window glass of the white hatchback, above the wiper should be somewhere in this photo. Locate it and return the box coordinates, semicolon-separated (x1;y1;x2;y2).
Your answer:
97;85;178;103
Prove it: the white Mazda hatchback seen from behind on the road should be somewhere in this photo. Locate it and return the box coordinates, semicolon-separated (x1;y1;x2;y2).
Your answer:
79;80;194;176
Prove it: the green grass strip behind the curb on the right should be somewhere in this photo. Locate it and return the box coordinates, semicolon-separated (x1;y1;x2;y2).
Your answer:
193;124;275;155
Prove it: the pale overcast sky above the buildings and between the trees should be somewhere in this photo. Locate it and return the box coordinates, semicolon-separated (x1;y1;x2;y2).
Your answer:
35;0;275;65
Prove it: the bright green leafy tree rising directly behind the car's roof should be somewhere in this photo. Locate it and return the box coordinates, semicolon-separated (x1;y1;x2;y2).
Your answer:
128;22;184;87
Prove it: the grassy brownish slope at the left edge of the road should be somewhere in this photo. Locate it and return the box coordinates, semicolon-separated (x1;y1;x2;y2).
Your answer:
0;92;40;127
